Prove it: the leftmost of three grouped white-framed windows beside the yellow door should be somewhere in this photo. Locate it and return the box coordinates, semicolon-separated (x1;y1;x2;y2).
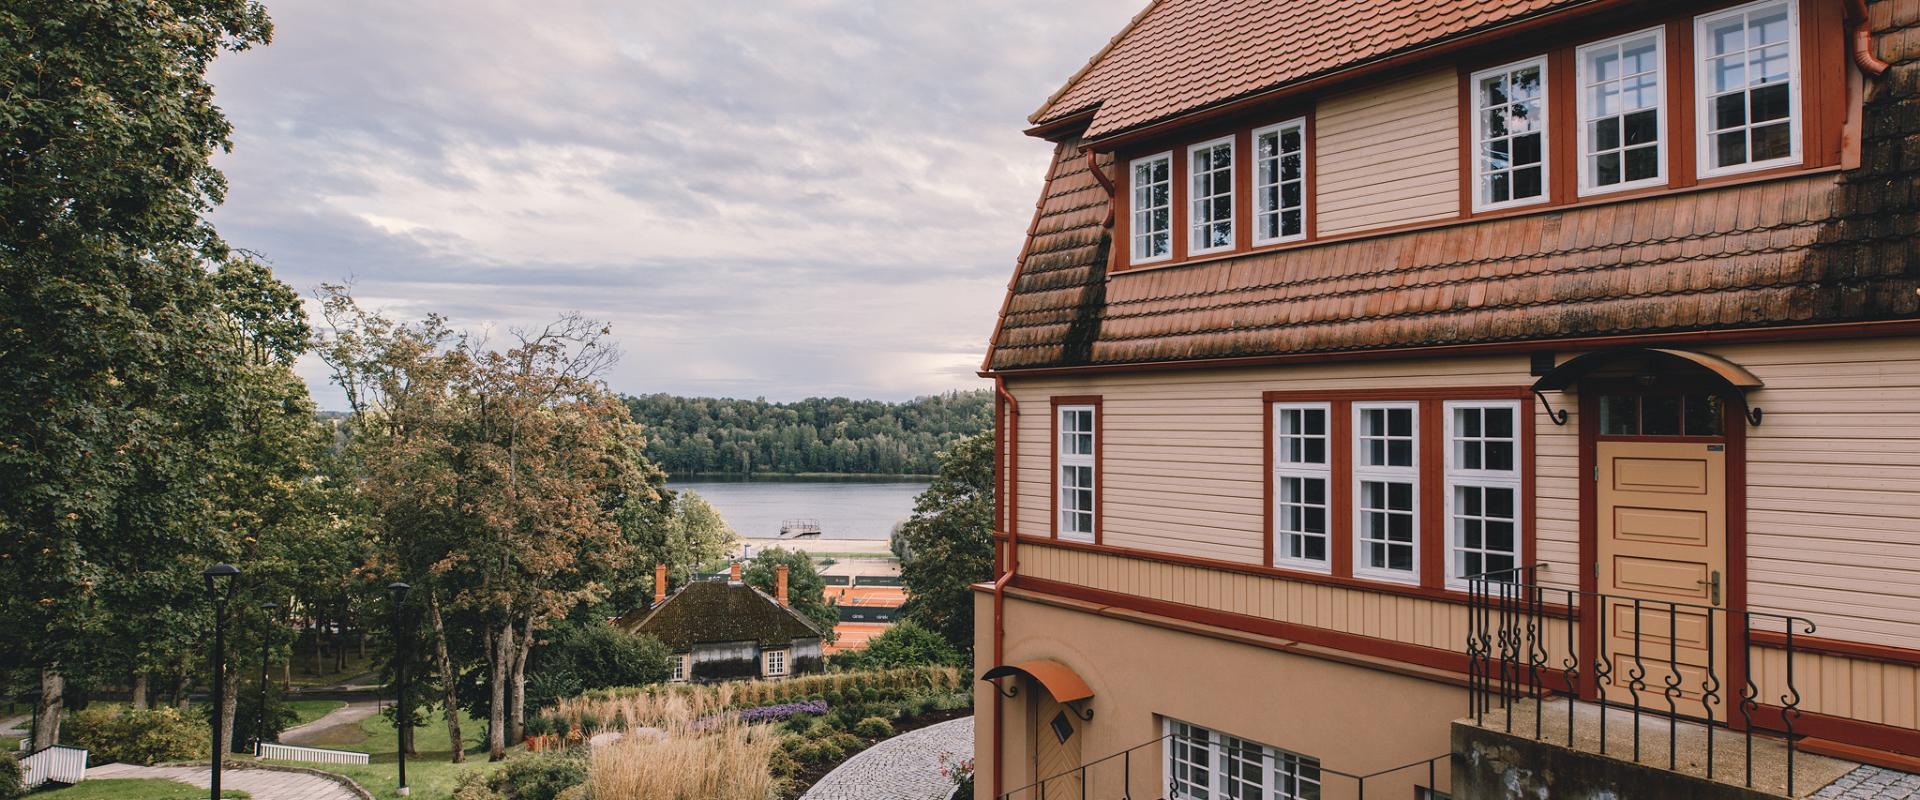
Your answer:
1273;403;1332;572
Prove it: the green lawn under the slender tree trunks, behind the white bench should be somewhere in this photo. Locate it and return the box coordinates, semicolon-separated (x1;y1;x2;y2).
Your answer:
269;714;499;800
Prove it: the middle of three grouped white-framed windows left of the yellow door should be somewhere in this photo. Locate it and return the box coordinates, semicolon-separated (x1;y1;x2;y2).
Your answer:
1354;403;1421;583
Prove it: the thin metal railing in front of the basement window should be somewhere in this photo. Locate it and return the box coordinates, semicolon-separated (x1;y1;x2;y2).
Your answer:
998;733;1452;800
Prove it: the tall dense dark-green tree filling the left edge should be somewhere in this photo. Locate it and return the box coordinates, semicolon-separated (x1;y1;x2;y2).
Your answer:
0;0;271;746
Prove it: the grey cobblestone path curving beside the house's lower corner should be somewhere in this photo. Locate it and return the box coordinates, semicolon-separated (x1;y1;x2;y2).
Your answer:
801;718;973;800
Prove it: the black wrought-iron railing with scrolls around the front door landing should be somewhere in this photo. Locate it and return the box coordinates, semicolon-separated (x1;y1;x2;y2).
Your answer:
1467;564;1814;796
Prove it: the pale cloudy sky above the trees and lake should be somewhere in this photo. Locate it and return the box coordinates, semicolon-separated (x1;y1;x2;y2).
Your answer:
211;0;1144;409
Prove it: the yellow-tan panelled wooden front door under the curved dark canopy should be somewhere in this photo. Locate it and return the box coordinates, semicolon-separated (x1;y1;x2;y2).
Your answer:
1594;437;1728;718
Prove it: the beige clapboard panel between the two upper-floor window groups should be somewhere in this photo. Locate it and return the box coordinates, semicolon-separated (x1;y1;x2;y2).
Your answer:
1313;71;1459;236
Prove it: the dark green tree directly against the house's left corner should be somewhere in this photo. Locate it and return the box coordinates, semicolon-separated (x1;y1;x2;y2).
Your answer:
900;430;993;650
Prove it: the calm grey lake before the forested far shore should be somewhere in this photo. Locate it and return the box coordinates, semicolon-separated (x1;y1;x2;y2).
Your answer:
666;478;927;541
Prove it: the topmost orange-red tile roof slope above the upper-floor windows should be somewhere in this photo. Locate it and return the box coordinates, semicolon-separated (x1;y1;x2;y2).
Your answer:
1031;0;1597;138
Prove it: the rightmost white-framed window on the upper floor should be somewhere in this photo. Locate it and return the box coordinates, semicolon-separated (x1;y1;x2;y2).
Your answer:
1693;0;1801;175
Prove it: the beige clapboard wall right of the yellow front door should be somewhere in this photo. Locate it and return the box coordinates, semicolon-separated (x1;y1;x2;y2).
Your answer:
1715;338;1920;648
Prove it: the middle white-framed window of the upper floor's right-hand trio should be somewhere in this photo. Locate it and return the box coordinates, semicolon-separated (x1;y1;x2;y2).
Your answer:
1574;27;1667;194
